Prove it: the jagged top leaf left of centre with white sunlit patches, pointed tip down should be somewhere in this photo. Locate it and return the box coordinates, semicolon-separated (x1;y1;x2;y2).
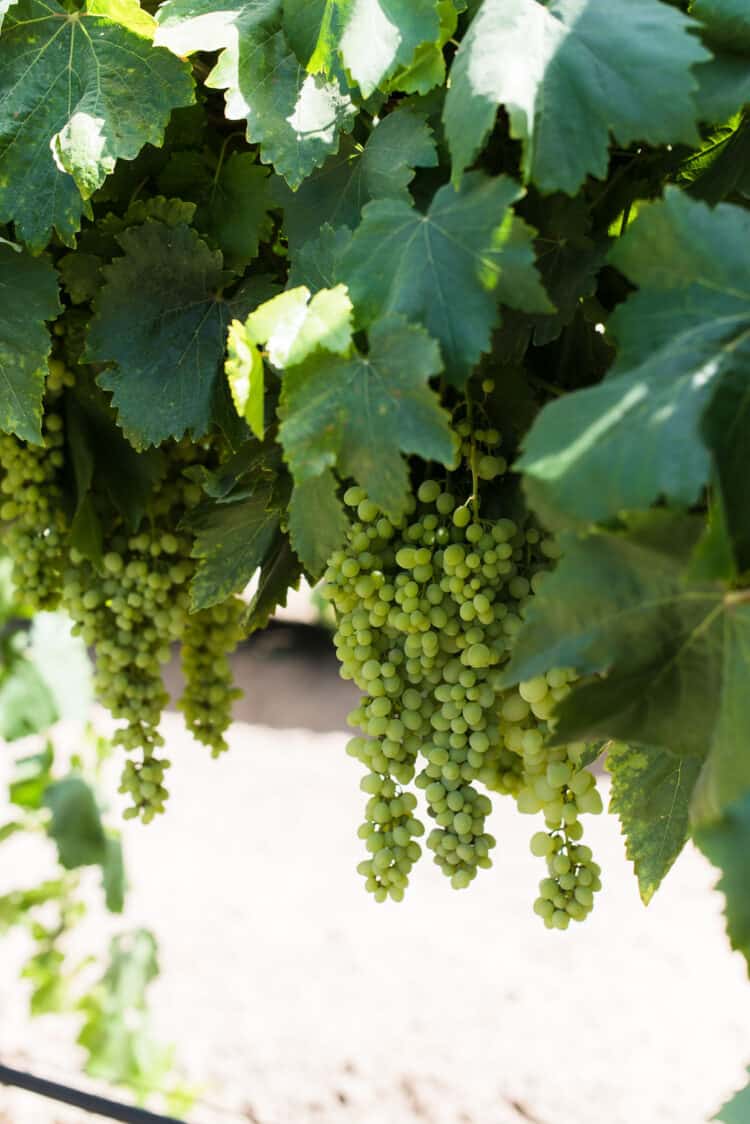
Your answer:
154;0;355;188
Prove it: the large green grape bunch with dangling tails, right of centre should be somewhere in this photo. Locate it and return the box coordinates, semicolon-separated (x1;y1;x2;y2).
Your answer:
324;420;602;928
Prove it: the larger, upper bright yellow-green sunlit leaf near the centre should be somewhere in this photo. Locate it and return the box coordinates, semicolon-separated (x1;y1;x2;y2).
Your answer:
245;284;352;370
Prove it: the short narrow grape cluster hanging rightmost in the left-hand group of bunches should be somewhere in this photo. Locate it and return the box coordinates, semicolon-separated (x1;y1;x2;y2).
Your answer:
180;597;245;758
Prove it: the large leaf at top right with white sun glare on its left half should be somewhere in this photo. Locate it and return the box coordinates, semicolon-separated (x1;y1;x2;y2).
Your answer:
444;0;708;194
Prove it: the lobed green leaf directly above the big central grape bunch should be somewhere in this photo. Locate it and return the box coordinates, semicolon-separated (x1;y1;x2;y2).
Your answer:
279;312;455;514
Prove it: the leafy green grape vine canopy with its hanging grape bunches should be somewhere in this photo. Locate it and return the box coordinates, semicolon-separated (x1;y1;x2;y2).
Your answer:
0;0;750;1097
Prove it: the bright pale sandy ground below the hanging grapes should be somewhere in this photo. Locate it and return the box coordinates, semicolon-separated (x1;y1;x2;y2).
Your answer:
0;701;750;1124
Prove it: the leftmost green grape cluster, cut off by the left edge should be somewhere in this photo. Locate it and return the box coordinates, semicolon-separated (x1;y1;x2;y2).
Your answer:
0;402;65;610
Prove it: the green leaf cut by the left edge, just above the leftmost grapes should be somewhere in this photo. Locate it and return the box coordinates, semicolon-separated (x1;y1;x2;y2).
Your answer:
0;245;61;444
